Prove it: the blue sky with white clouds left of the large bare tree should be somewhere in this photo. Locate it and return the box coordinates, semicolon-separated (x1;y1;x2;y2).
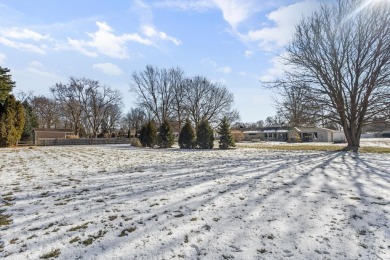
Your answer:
0;0;320;122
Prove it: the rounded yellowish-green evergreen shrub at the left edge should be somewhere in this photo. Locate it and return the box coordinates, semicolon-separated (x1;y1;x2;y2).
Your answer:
0;95;25;147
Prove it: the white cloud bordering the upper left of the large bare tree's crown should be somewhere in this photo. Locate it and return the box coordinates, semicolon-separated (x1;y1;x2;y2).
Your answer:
243;0;320;50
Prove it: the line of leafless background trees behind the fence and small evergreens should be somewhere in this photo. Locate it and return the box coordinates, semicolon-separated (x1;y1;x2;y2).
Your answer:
0;66;239;146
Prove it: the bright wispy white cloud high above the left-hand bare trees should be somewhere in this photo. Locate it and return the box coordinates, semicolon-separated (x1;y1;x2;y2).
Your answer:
68;22;153;59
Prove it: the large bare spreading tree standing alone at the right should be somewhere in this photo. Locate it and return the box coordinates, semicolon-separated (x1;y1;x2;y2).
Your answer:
287;0;390;152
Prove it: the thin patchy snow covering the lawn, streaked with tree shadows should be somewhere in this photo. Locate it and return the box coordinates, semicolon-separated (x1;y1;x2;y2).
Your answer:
0;145;390;259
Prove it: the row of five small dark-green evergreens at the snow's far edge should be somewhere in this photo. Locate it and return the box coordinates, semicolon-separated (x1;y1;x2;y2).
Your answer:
139;117;235;149
